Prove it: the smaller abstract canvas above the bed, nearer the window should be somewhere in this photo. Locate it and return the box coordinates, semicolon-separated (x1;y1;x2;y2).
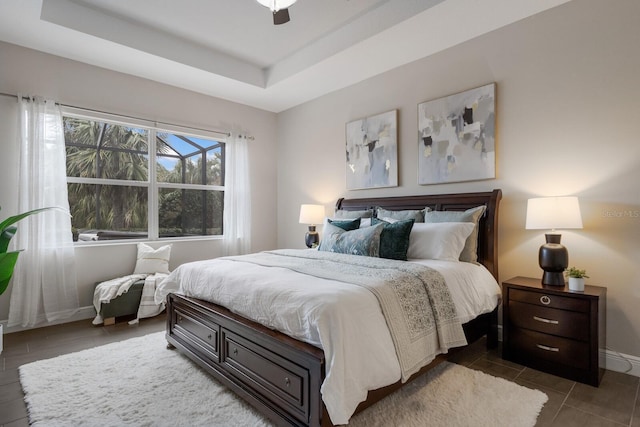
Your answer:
346;110;398;190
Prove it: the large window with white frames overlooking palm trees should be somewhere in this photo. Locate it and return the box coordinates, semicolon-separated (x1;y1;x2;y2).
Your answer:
63;111;225;241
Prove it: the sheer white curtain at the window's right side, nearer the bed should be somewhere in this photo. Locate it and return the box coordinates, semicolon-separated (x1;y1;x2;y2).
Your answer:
223;135;251;255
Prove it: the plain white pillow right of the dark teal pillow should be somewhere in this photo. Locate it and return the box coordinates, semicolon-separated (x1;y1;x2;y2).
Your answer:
407;222;475;261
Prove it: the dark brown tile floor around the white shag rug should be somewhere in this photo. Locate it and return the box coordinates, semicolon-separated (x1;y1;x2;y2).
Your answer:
0;315;640;427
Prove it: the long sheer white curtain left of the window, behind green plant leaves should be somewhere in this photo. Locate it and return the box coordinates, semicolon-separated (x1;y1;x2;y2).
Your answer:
8;96;79;327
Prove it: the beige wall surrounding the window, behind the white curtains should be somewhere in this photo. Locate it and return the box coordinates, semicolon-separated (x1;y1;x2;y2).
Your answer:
0;43;276;321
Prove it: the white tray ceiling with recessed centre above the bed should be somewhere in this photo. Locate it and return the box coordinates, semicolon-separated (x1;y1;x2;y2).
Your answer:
0;0;568;112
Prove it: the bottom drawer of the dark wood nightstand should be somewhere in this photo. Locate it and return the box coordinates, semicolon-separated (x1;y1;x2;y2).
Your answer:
509;328;590;369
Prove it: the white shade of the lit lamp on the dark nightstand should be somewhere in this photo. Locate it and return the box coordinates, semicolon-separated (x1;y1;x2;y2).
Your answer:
525;197;582;230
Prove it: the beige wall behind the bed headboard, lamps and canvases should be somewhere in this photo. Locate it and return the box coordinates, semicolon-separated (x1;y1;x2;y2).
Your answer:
278;0;640;357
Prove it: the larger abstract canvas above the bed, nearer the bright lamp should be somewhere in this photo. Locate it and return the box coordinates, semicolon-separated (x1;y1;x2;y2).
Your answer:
418;83;496;184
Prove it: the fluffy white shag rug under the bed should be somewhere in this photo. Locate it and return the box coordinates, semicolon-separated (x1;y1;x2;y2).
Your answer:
20;332;547;427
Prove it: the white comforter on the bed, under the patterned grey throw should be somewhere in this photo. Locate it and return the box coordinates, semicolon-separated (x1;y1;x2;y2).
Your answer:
155;252;500;425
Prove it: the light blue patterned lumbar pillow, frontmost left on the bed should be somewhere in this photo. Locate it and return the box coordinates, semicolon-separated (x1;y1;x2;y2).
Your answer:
318;222;384;257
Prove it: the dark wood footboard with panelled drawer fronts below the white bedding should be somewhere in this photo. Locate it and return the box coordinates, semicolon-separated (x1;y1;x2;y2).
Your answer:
166;294;331;426
